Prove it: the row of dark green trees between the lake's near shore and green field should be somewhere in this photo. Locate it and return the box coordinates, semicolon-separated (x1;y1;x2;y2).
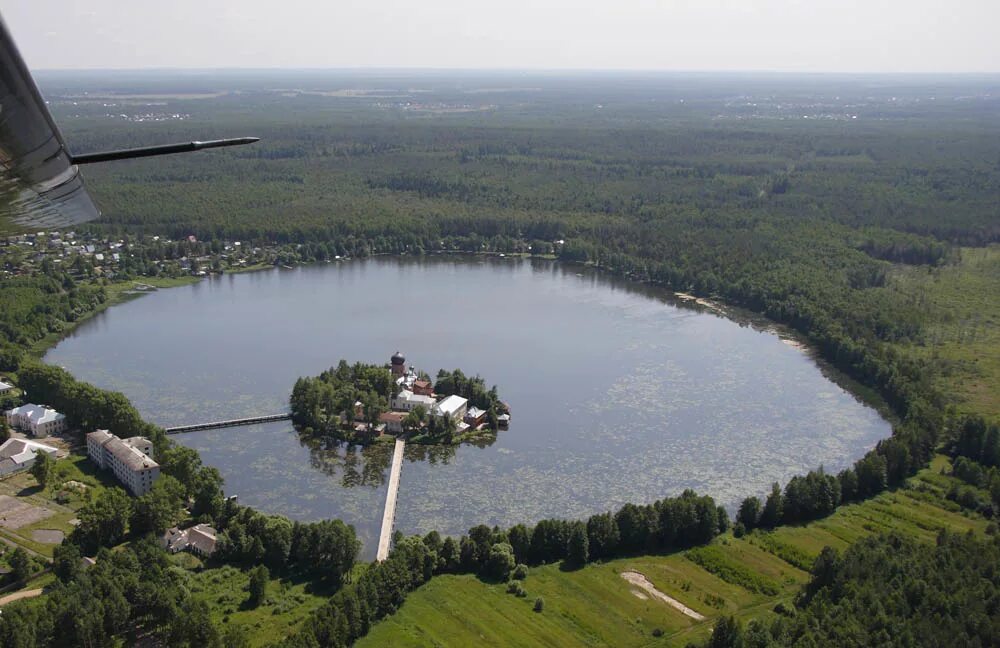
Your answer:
282;490;729;648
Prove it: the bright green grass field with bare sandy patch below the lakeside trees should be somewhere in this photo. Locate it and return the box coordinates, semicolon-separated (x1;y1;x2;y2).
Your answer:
358;457;987;648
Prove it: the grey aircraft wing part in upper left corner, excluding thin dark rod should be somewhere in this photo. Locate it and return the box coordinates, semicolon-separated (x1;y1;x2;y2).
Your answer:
0;18;100;231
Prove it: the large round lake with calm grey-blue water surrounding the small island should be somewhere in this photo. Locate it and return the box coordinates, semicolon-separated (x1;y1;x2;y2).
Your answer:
45;258;890;557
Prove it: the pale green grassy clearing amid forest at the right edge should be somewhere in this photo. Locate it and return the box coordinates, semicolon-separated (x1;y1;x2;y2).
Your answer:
891;245;1000;419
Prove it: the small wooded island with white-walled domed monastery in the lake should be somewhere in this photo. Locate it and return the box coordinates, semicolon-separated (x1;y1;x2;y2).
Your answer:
289;351;510;445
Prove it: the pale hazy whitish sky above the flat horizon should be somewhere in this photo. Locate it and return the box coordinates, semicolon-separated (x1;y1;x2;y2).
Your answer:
0;0;1000;73
